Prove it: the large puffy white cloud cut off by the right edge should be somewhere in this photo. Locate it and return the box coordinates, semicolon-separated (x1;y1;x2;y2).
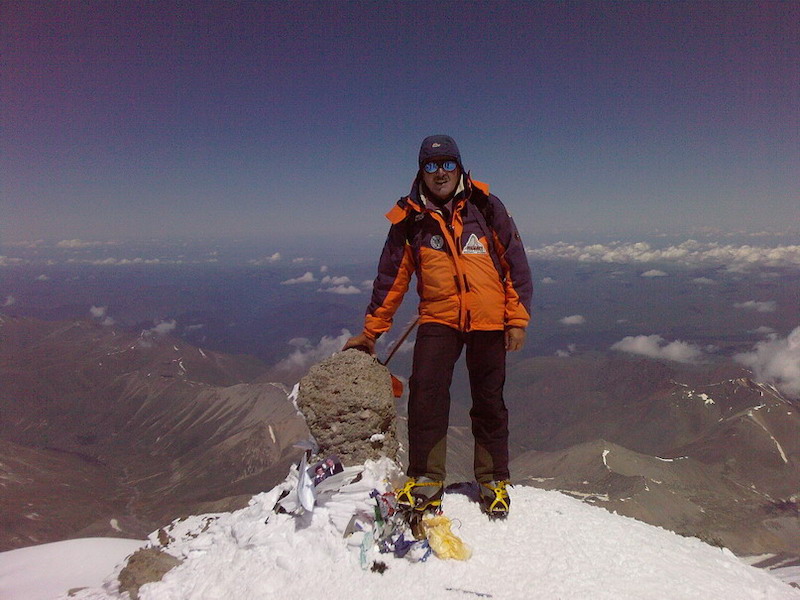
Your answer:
733;327;800;398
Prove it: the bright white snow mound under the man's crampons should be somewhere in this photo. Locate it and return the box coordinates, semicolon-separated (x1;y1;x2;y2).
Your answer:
47;459;800;600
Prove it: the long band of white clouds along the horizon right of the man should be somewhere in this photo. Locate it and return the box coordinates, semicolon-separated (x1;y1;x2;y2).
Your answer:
527;240;800;271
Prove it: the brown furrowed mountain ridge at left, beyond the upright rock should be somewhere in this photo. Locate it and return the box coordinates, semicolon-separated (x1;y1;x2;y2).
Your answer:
0;317;308;548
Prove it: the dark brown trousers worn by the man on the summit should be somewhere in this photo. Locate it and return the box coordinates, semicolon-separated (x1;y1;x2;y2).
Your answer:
408;323;509;482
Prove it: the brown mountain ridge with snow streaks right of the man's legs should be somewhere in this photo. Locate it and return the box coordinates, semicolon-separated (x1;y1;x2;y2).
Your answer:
510;356;800;554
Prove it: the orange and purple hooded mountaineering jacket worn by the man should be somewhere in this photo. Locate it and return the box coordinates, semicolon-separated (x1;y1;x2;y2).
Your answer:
364;174;533;339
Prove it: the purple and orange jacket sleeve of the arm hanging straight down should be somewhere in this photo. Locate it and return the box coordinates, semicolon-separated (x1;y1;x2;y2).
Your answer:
489;195;533;327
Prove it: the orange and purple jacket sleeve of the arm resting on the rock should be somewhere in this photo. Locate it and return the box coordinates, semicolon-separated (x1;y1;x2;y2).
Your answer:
364;211;414;339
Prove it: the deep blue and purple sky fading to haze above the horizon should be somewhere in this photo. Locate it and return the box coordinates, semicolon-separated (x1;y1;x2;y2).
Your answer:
0;0;800;243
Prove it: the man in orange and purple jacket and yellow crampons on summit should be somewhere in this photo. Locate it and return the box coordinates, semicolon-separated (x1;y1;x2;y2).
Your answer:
345;135;532;518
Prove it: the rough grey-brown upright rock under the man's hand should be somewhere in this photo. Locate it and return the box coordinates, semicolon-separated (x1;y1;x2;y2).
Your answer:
297;349;398;465
